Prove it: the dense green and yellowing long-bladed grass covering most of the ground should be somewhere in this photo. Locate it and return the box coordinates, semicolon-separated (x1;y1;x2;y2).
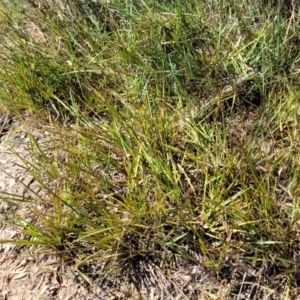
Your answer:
0;0;300;299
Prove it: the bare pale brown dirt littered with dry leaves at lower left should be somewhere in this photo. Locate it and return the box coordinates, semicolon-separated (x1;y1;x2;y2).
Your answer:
0;115;97;300
